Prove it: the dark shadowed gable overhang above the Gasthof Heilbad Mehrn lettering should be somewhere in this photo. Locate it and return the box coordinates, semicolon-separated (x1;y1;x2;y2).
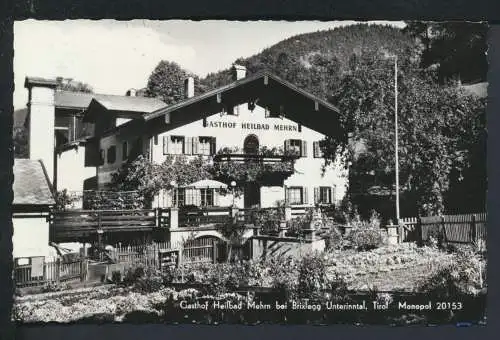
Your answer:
142;72;340;135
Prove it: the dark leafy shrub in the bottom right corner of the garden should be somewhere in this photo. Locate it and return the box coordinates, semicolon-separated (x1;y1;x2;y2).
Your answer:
418;249;486;298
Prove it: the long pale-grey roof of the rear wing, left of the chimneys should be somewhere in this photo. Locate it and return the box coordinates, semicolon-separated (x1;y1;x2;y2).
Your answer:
55;91;165;113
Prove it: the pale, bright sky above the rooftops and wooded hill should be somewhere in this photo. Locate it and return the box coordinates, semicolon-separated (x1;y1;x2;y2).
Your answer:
14;19;404;110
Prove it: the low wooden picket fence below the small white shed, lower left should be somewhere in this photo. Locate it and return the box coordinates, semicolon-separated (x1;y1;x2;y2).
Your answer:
13;257;87;288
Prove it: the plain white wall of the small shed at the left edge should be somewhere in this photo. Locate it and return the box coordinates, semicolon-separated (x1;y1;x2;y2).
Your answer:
12;216;52;258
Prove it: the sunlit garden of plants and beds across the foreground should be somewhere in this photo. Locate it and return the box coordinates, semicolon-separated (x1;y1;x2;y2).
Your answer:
12;214;486;325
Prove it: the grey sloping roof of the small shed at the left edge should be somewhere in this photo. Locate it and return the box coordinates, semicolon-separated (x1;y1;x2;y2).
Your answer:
12;159;55;205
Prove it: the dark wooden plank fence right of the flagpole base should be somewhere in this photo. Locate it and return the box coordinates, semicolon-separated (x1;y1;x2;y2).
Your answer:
399;213;487;244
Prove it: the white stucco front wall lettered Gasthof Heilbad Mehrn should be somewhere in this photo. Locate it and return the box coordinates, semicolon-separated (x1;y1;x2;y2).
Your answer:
98;104;347;207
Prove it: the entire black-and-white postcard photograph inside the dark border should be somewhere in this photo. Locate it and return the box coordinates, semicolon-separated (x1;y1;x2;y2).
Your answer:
11;19;489;326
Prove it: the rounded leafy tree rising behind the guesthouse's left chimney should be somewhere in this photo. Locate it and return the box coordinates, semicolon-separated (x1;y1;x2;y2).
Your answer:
145;60;207;104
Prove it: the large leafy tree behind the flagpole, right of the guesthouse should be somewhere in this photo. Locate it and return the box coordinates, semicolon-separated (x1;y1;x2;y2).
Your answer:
321;51;485;214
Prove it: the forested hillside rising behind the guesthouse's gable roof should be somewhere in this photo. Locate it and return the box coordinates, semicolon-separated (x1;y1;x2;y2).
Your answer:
201;24;421;99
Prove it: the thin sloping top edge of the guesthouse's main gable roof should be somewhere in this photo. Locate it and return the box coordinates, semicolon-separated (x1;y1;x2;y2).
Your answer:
143;71;340;120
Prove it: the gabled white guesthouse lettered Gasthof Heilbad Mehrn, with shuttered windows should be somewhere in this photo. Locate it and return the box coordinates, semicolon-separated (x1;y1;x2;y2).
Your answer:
84;65;347;208
